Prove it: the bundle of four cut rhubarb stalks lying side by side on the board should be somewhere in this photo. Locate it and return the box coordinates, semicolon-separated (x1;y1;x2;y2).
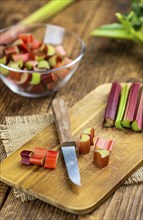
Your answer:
103;82;143;131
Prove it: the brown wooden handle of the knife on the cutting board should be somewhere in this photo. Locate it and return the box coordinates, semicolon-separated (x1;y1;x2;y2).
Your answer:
52;99;75;146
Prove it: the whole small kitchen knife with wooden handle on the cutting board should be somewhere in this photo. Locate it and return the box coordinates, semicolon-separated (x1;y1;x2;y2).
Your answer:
52;99;81;186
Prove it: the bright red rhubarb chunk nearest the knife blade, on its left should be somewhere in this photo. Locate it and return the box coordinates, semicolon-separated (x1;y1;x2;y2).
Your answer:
44;150;59;169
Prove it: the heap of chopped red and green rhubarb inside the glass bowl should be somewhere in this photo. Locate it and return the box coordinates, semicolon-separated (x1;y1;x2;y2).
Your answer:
0;33;73;93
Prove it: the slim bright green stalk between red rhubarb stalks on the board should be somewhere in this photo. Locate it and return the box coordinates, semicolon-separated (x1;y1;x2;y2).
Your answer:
115;85;130;129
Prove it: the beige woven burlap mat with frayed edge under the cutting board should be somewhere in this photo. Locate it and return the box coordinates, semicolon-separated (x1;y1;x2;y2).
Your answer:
0;114;143;202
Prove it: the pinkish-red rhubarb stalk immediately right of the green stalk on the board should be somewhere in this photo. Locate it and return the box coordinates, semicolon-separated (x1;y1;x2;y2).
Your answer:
122;83;140;128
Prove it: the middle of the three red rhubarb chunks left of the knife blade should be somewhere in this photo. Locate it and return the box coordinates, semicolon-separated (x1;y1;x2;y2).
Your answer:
30;147;47;166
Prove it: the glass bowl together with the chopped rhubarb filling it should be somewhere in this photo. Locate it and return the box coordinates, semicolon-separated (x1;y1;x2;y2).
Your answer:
0;24;85;98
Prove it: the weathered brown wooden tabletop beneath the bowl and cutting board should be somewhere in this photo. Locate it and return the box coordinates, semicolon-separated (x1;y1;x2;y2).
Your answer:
0;0;143;220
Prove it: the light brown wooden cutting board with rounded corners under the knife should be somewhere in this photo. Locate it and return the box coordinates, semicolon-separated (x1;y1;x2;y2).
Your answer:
1;84;143;214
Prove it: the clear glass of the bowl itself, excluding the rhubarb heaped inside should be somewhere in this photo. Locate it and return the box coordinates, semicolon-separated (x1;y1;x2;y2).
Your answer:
0;24;85;98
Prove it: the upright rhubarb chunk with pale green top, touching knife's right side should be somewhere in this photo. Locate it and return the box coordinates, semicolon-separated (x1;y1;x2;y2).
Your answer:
78;134;90;154
